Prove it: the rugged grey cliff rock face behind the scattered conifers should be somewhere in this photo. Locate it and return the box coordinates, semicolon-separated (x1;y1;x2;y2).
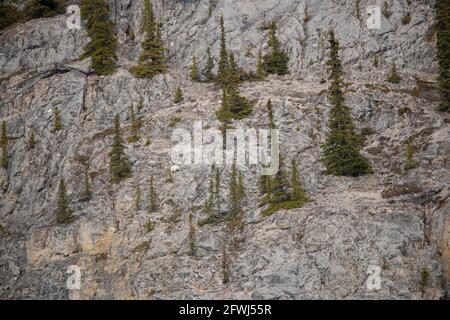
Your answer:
0;0;450;299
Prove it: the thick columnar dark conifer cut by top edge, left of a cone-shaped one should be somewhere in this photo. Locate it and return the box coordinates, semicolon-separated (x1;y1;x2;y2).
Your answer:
81;0;117;75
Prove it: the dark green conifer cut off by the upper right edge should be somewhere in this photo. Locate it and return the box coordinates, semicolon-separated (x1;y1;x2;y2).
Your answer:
436;0;450;112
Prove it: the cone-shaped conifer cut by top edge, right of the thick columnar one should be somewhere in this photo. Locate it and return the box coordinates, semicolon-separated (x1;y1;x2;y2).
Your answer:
130;0;167;78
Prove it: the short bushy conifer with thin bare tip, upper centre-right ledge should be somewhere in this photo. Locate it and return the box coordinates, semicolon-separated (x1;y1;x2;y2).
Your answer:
264;21;289;75
